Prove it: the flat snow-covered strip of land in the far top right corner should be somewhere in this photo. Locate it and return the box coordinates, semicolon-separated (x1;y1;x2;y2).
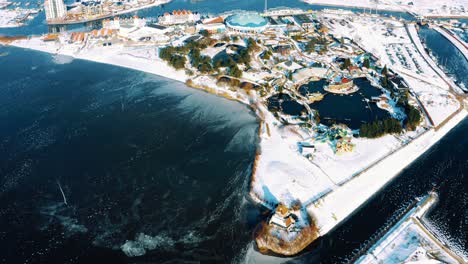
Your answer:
303;0;468;16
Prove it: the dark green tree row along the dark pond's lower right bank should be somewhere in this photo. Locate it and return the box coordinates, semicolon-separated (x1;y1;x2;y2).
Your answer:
359;118;403;138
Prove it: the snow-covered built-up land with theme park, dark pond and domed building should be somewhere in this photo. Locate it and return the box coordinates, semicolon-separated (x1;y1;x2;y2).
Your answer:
3;0;467;256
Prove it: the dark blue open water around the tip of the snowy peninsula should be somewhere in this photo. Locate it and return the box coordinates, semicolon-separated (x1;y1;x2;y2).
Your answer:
0;1;468;263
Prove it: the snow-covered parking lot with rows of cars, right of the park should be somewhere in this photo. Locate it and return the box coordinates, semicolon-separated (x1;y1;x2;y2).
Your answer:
327;15;460;126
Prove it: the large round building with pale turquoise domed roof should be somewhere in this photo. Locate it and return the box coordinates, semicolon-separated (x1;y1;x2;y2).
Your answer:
226;12;268;33
